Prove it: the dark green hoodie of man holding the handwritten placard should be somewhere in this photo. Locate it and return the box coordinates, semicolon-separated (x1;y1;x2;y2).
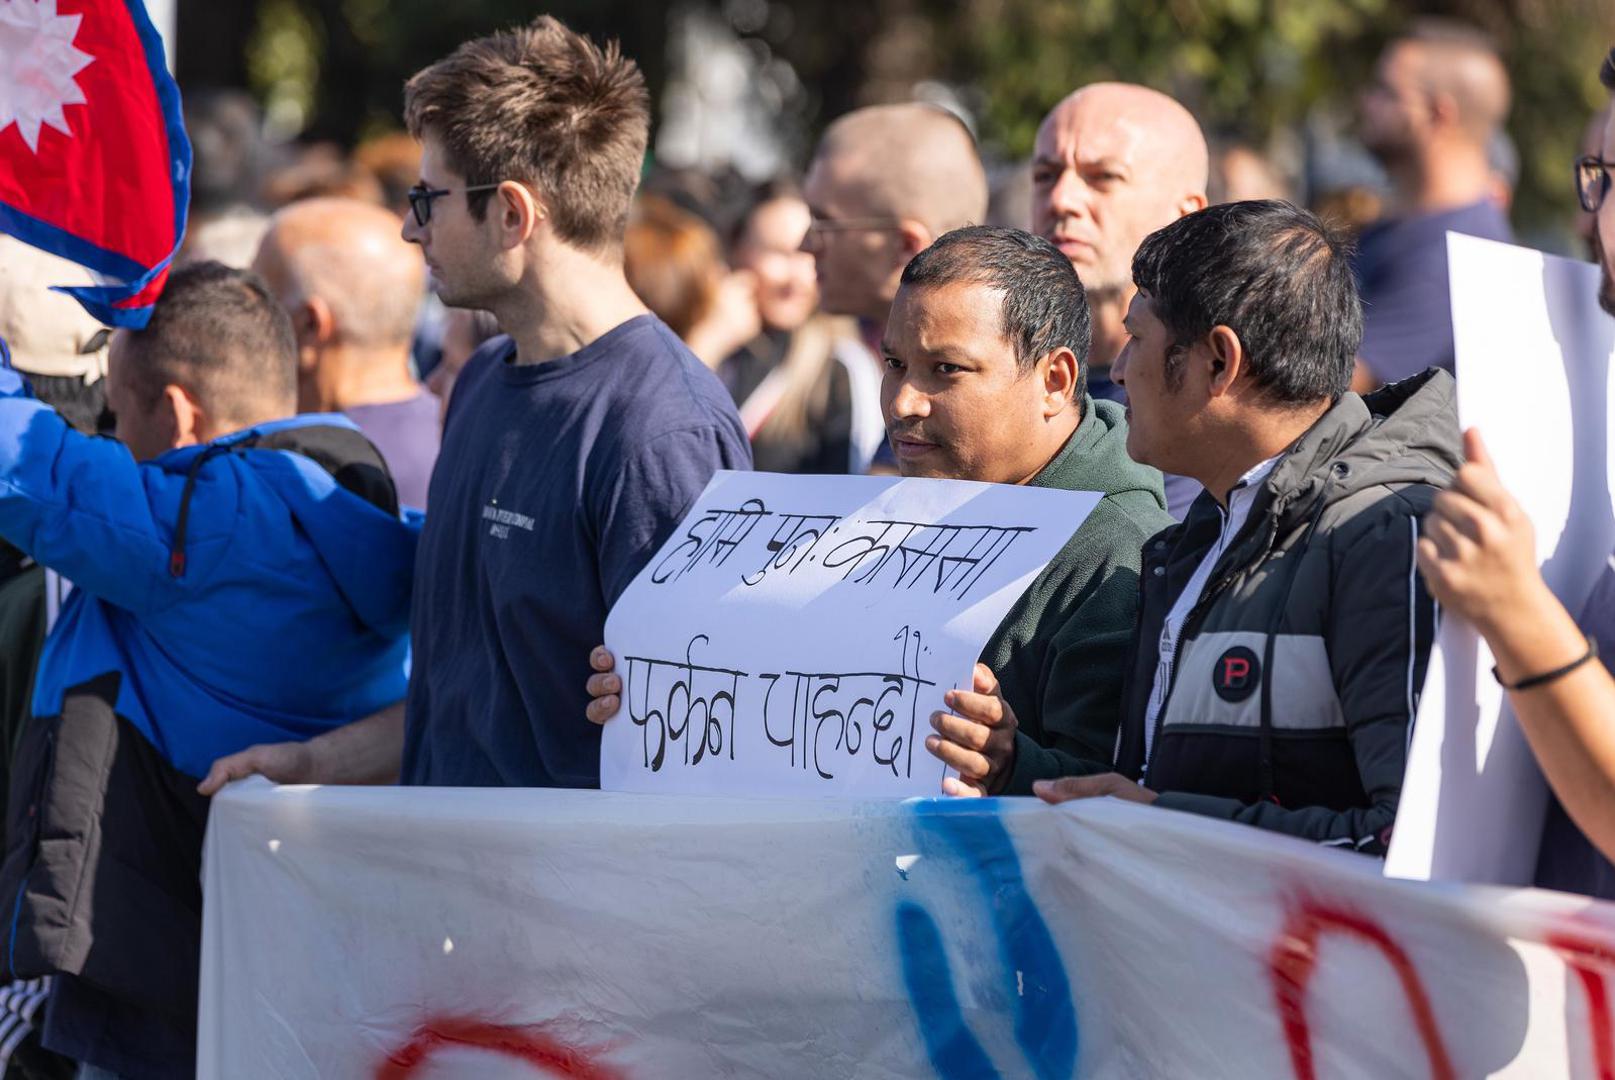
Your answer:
982;396;1174;794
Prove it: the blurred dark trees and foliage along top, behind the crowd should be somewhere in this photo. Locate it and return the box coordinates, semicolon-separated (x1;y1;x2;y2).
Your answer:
176;0;1615;237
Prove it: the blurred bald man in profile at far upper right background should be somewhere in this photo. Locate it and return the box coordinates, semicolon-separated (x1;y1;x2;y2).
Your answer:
1352;19;1513;391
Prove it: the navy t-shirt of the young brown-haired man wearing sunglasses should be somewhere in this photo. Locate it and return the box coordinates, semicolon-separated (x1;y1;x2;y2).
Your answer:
404;315;751;788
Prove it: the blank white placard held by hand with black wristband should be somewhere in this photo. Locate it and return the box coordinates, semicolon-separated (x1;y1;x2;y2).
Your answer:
1386;232;1615;885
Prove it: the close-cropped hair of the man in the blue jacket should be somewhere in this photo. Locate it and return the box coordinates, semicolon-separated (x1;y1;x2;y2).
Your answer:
124;262;297;418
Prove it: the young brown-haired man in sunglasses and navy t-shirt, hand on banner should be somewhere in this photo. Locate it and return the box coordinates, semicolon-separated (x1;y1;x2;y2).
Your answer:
208;16;751;788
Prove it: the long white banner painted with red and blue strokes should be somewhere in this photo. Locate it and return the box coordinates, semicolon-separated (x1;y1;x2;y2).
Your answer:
200;781;1615;1080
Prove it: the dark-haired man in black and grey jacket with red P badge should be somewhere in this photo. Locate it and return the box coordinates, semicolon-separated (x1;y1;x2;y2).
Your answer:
1001;202;1462;854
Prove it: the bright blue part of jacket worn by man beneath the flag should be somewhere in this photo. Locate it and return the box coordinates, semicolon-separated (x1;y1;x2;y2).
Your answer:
0;362;420;777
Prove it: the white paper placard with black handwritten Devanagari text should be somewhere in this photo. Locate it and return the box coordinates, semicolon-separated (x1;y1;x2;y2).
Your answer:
601;471;1100;797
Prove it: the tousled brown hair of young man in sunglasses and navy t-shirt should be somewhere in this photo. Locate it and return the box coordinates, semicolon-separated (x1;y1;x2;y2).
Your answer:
404;15;651;250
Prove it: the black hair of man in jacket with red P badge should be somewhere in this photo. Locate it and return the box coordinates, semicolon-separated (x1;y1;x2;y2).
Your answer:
1132;199;1363;405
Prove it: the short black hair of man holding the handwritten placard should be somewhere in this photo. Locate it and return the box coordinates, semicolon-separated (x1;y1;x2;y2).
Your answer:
903;224;1092;392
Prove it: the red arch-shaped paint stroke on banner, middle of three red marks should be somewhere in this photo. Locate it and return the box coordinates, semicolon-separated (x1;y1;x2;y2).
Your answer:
1268;902;1458;1080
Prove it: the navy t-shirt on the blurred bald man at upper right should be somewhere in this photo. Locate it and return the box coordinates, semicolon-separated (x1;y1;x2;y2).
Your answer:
1353;202;1513;383
